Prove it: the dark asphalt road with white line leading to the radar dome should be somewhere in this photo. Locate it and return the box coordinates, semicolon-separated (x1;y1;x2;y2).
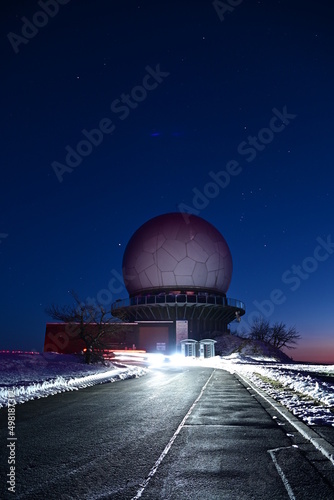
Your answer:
0;366;334;500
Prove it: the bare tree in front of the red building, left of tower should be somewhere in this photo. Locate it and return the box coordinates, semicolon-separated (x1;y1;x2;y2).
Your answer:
45;291;124;363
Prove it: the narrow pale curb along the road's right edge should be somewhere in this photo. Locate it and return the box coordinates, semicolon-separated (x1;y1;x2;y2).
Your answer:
234;372;334;465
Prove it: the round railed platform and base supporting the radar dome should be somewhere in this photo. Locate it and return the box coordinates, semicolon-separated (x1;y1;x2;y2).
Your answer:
111;294;245;354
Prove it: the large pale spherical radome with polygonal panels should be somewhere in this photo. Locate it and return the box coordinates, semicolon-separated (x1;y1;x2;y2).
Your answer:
123;212;232;296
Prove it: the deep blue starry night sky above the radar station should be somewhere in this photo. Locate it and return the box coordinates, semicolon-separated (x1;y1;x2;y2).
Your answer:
0;0;334;363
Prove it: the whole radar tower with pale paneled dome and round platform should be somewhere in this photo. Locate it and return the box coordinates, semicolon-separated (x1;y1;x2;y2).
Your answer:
111;212;245;353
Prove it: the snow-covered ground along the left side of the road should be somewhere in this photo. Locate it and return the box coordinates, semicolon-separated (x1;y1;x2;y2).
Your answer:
0;353;147;408
